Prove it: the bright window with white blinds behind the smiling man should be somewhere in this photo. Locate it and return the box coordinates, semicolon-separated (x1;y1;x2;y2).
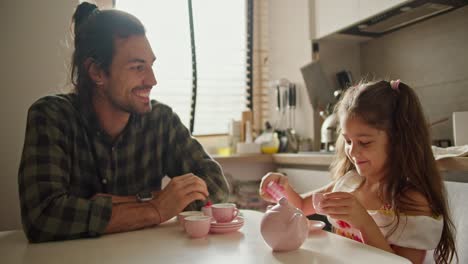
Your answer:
116;0;248;135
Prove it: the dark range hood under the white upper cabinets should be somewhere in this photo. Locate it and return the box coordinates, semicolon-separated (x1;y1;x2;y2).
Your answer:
339;0;468;37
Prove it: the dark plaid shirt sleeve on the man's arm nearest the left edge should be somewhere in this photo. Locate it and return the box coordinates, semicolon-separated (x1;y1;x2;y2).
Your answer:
18;103;112;242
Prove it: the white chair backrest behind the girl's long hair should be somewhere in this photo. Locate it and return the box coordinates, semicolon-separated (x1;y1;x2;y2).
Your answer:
445;181;468;263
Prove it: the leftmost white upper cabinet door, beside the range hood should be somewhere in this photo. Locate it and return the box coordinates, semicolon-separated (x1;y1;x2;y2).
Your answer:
315;0;359;38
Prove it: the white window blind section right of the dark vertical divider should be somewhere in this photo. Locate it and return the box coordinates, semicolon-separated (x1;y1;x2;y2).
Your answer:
192;0;247;135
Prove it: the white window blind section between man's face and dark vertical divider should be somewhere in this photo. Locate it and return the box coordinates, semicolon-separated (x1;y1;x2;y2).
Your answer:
116;0;192;127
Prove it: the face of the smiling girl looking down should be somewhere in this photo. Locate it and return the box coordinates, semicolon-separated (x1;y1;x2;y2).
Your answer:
341;117;389;179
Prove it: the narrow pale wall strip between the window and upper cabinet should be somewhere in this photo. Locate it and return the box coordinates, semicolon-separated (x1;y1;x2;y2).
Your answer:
268;0;314;142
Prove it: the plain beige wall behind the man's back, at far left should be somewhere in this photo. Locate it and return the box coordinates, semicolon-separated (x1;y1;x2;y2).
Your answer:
0;0;78;230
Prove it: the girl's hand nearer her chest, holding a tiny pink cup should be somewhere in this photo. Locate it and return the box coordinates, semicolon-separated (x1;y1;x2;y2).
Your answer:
320;192;372;229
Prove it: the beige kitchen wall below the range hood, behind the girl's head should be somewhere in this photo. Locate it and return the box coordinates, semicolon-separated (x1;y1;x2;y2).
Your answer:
360;7;468;143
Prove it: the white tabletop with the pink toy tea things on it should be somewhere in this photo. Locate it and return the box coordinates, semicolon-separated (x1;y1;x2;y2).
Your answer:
0;210;410;264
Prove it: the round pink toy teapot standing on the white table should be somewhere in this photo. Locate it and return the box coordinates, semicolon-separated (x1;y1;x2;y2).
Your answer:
260;197;309;251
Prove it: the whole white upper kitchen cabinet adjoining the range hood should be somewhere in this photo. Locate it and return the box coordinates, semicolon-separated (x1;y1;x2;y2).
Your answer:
309;0;408;39
